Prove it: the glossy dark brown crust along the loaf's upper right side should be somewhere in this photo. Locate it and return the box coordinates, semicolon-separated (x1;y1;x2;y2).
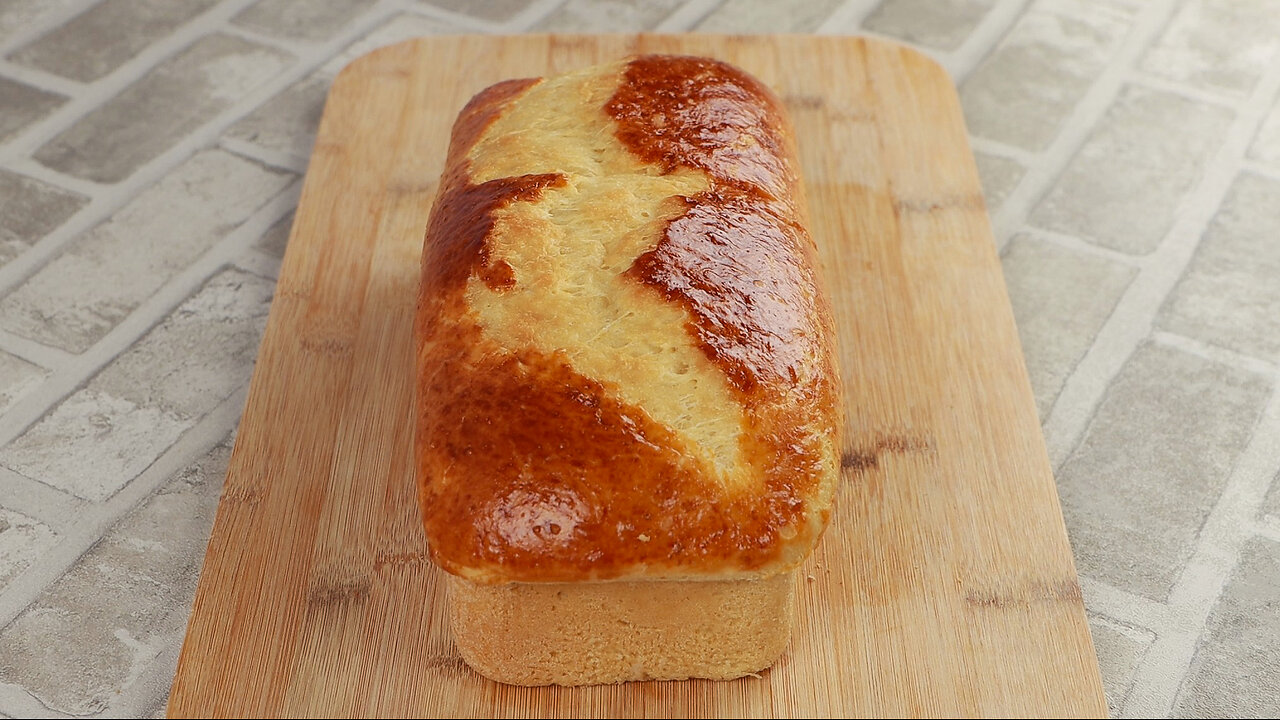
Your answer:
605;55;831;393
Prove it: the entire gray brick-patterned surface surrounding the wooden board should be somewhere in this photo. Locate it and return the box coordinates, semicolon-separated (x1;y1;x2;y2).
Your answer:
0;0;1280;717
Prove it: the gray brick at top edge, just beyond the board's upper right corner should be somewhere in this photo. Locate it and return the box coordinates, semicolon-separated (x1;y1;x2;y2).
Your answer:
863;0;995;50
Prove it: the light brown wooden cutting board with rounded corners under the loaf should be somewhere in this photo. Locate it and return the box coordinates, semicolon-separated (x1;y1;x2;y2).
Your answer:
169;36;1106;717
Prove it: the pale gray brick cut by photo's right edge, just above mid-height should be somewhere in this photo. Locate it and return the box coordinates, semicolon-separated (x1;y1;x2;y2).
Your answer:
1156;173;1280;363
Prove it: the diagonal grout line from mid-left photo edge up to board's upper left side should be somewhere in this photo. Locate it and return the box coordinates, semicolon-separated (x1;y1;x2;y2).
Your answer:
0;179;302;446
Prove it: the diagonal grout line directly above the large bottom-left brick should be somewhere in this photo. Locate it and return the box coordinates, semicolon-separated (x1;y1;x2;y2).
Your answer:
0;382;248;630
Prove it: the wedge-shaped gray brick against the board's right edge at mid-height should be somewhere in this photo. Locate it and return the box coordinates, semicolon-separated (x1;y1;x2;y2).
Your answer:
1001;236;1134;419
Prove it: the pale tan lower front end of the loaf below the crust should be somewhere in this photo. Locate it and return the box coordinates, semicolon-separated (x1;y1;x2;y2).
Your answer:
448;573;796;685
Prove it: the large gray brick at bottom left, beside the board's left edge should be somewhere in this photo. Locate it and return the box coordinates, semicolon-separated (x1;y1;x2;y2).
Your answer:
0;443;230;715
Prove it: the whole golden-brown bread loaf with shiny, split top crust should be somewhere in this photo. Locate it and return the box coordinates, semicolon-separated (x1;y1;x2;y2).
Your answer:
416;55;841;685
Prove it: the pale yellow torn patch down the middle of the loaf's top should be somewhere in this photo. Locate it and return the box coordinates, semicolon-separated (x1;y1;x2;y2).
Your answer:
466;64;755;489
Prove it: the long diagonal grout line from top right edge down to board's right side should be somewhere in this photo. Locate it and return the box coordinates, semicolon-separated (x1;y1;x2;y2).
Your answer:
991;0;1176;249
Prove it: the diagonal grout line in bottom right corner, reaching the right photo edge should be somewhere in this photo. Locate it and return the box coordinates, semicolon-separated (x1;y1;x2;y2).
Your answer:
1121;379;1280;717
